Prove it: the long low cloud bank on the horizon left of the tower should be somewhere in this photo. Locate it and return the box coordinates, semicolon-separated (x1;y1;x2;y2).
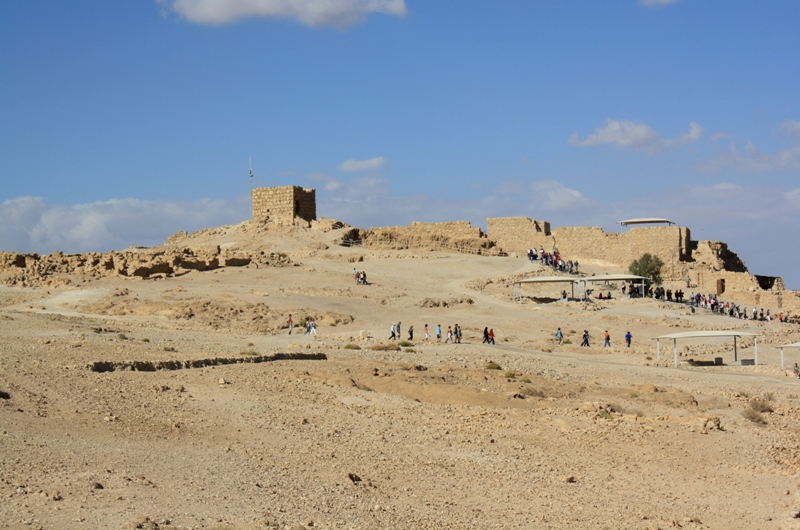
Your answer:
0;196;251;253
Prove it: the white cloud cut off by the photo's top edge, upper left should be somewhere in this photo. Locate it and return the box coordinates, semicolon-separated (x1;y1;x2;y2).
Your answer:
157;0;407;28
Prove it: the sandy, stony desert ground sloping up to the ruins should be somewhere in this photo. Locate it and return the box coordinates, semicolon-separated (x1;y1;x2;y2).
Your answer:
0;223;800;530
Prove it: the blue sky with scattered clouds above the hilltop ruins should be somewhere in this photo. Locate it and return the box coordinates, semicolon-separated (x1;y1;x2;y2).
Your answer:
0;0;800;289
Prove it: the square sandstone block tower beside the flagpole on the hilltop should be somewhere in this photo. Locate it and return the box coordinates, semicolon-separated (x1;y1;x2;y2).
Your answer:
252;186;317;226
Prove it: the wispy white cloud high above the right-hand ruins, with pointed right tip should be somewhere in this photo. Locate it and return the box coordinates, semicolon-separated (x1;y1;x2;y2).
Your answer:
569;119;703;155
